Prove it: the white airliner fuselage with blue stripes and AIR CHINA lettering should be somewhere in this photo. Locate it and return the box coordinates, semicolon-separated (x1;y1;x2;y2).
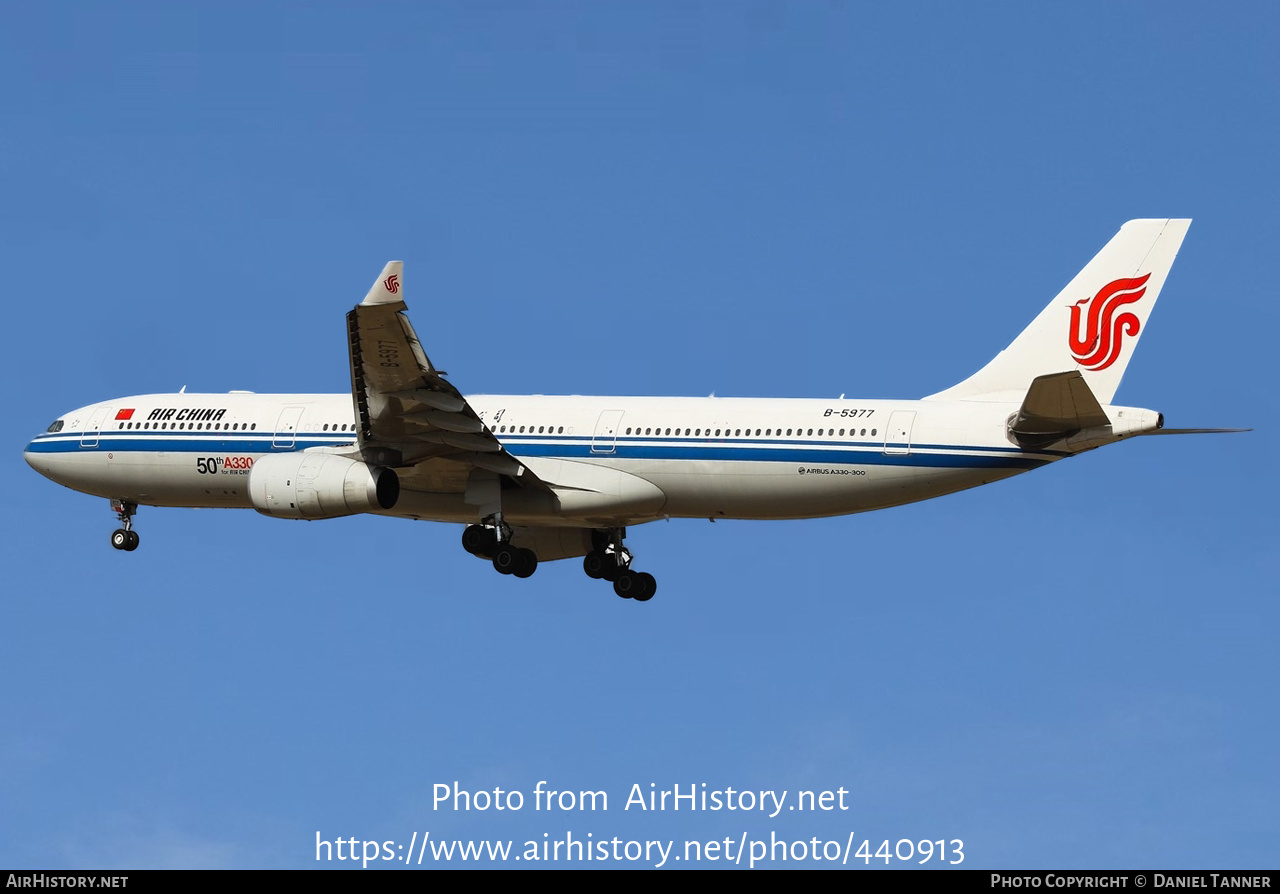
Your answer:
26;393;1075;526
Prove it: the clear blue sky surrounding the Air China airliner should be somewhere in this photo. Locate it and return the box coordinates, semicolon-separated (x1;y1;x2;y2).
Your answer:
0;3;1280;868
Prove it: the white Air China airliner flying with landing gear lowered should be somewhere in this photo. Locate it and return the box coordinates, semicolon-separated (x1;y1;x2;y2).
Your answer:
23;219;1247;602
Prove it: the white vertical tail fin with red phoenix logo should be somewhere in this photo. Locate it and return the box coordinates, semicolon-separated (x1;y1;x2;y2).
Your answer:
925;219;1192;403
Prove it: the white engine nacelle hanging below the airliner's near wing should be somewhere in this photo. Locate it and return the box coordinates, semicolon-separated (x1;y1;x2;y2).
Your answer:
248;453;399;519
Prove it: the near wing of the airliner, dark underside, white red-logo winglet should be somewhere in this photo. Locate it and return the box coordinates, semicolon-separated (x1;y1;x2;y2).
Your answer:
347;261;547;493
